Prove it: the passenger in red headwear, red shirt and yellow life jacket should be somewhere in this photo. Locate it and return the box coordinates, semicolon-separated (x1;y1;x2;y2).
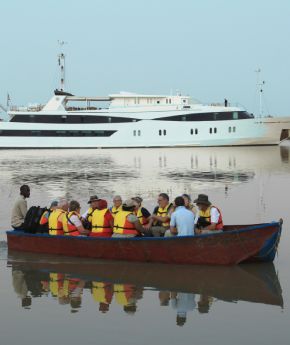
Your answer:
90;199;114;237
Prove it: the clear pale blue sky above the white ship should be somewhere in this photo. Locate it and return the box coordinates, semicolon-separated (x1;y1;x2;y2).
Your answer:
0;0;290;116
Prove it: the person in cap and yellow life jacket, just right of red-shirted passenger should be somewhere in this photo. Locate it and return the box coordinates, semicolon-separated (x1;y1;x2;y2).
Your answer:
112;199;144;237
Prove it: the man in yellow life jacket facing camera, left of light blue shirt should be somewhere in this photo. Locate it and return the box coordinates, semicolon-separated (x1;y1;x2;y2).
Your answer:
144;193;174;237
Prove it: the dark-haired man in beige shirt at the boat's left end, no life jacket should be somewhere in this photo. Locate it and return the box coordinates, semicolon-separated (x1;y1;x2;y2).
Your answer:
11;184;30;230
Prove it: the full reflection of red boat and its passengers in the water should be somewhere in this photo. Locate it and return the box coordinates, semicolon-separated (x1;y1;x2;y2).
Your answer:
7;251;283;326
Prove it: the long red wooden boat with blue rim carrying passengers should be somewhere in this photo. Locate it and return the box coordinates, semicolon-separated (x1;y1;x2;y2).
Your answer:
7;222;282;265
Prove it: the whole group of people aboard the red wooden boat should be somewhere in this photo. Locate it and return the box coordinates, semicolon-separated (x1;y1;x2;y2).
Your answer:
11;185;223;237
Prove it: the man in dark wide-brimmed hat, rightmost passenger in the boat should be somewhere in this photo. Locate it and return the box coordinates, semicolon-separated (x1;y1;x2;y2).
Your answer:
194;194;224;234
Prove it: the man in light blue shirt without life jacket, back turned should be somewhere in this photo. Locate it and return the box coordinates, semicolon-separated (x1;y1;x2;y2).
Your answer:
165;196;194;237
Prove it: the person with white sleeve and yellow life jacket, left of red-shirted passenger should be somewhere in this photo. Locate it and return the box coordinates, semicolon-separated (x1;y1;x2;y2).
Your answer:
62;200;90;236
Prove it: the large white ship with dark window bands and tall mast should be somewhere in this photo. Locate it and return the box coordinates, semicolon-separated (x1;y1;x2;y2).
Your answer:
0;54;290;148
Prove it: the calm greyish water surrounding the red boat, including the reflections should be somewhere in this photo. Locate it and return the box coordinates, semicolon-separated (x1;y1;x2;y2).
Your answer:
0;144;290;345
